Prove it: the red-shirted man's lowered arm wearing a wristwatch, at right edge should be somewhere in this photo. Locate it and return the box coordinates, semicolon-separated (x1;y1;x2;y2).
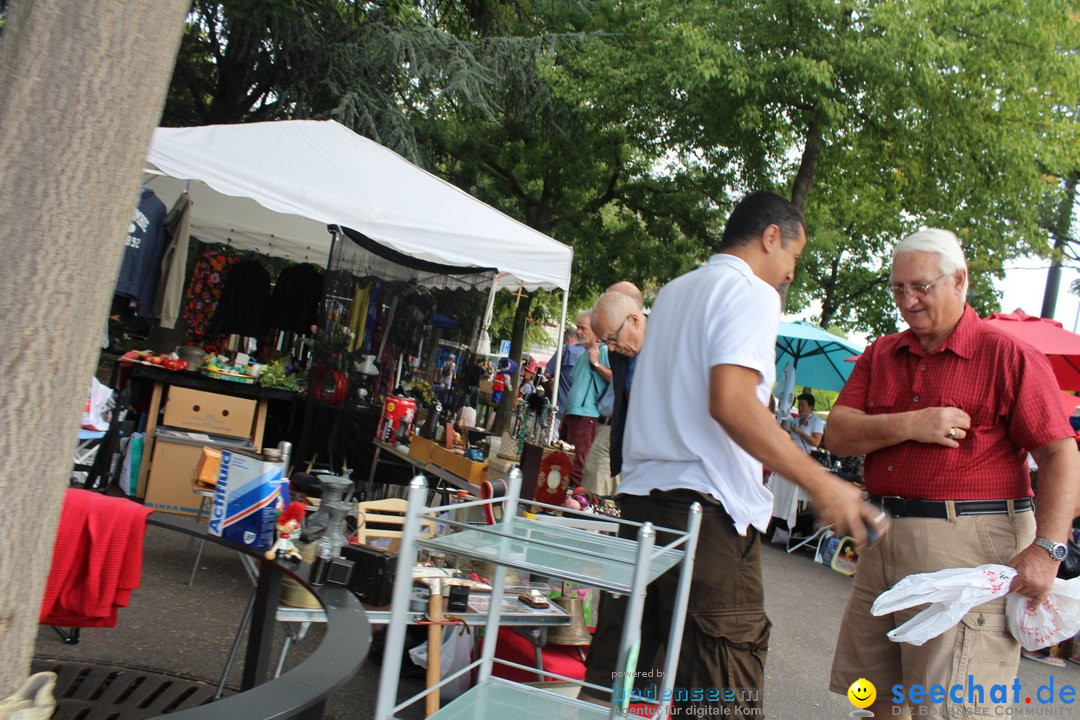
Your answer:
1009;437;1080;600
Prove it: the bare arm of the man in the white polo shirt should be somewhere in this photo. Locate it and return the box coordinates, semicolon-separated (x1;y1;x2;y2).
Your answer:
708;365;888;545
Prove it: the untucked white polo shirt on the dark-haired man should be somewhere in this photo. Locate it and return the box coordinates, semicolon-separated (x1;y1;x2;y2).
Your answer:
619;254;780;534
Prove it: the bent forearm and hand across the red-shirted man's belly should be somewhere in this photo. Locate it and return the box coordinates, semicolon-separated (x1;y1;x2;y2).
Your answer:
827;405;971;456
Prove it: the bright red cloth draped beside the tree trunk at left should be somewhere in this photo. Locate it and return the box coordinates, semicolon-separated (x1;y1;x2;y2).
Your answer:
38;488;153;627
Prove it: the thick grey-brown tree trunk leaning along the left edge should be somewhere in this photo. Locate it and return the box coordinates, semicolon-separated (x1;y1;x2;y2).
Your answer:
0;0;188;697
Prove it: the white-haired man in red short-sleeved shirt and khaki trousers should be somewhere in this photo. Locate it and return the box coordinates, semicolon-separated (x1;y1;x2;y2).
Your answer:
826;230;1080;717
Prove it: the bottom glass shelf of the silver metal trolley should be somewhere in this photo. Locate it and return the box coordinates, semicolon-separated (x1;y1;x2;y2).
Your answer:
408;678;611;720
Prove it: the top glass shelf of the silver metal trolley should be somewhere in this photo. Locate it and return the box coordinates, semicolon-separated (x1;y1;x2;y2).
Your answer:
417;517;684;594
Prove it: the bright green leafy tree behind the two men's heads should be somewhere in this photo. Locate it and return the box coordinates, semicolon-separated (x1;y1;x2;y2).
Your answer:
583;0;1080;331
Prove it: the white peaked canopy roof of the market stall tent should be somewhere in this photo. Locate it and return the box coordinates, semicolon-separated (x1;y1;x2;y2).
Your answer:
145;120;573;290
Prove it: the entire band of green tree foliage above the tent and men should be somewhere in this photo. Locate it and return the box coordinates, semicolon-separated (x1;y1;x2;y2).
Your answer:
159;0;1080;337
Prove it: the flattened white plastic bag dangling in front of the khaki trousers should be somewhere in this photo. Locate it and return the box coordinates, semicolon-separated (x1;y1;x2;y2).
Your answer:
870;565;1016;646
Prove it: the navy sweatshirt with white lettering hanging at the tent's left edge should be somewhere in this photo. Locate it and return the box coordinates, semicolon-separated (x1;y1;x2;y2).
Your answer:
116;188;165;315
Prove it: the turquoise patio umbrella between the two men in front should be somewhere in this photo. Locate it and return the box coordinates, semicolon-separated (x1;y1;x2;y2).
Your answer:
777;321;863;391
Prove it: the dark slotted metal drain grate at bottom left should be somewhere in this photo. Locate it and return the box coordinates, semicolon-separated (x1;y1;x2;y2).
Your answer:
33;658;225;720
